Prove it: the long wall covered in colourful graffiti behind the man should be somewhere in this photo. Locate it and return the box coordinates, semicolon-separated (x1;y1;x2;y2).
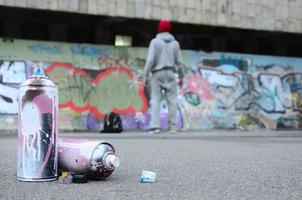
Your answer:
0;38;302;131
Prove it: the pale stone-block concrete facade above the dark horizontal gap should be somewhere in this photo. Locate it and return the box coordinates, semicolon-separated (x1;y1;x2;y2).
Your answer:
0;0;302;33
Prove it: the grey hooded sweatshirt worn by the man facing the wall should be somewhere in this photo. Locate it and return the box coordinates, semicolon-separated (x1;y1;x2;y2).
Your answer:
144;32;183;79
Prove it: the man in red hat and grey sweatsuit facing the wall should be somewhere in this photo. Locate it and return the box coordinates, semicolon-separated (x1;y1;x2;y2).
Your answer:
144;19;184;134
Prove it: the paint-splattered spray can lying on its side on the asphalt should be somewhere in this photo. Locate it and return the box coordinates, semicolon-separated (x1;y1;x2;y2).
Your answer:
58;139;120;179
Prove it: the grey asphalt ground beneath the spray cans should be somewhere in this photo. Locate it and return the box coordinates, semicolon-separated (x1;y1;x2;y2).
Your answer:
0;130;302;200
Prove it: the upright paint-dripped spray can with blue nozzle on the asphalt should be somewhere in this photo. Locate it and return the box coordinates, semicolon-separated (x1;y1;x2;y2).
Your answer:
17;68;58;181
